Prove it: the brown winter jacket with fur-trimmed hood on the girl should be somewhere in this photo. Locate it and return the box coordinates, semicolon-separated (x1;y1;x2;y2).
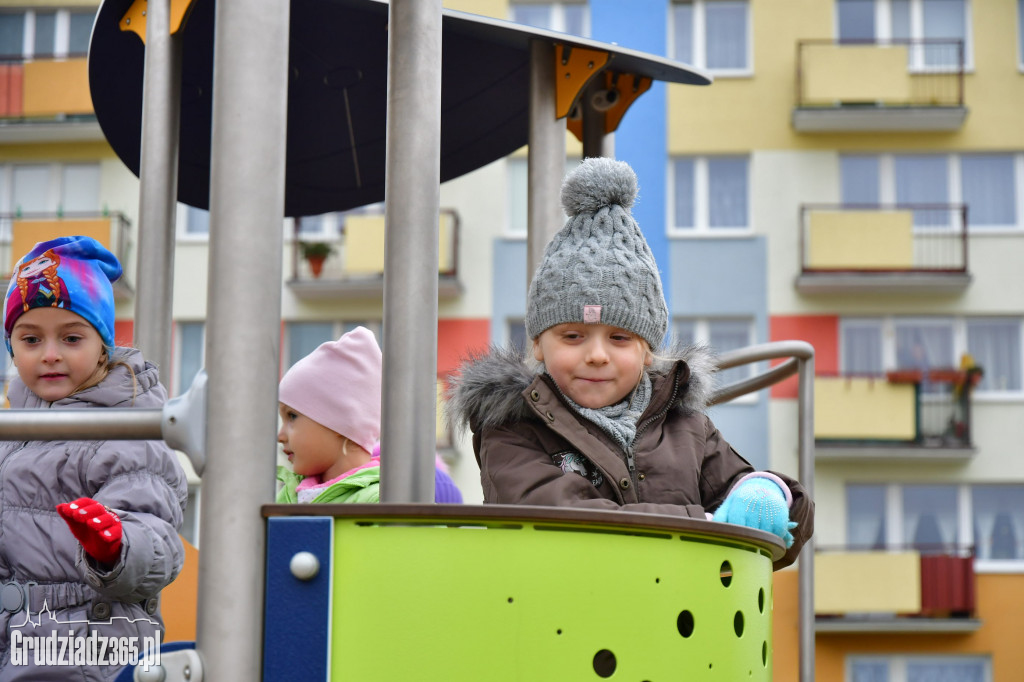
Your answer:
449;347;814;569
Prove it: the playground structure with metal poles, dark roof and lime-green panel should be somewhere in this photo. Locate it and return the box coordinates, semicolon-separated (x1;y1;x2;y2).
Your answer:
0;0;813;681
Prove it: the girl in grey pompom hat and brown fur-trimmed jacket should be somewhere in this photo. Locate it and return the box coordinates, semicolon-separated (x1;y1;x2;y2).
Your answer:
447;159;814;568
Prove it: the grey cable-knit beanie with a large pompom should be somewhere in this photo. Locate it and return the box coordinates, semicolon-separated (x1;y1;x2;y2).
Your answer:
526;158;669;350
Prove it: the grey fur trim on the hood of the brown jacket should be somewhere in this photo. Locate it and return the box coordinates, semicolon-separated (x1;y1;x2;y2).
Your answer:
445;345;718;432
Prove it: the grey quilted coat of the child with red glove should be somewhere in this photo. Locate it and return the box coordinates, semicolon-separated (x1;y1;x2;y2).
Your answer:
0;348;187;682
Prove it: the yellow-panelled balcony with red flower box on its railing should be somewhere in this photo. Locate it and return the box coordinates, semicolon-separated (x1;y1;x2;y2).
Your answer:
814;368;981;462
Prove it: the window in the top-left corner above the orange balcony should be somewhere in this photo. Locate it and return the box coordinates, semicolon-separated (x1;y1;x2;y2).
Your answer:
0;8;96;58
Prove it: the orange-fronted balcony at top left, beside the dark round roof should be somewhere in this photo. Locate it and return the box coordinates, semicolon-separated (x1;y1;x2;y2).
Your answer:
0;55;103;142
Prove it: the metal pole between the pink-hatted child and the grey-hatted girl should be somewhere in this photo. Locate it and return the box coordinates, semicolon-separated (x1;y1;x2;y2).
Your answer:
381;0;441;503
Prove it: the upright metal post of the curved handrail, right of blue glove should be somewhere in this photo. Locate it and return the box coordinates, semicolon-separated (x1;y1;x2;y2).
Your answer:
797;348;814;682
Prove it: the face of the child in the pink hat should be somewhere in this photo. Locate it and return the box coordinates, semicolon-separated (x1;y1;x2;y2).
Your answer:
278;402;351;480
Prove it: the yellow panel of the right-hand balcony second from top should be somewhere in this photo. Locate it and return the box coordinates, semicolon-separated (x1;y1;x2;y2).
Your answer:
807;211;913;269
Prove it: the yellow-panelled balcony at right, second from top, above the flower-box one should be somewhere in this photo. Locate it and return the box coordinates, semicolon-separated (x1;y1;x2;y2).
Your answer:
796;204;971;295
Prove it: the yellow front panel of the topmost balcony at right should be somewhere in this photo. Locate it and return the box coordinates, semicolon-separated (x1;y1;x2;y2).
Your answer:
803;44;910;104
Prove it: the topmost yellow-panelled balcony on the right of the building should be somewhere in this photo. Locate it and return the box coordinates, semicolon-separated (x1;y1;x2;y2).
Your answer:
793;39;967;133
